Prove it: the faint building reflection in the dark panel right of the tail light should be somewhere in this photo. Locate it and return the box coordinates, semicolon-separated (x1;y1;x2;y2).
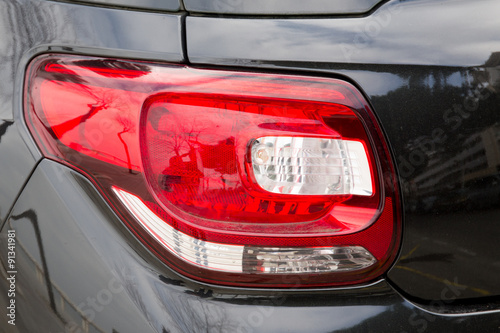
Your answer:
414;123;500;196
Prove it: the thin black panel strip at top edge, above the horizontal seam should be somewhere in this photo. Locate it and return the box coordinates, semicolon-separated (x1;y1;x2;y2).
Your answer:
184;0;382;15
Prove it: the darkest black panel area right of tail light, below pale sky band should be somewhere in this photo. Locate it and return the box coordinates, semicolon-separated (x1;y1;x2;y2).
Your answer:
364;60;500;301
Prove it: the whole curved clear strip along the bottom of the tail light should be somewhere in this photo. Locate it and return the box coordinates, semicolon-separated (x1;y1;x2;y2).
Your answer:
113;187;377;274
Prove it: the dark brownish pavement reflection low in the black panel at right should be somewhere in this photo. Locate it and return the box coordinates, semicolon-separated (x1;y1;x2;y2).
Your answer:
389;208;500;300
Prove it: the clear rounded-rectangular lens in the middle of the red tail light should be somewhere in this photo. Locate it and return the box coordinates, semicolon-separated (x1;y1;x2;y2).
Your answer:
251;136;373;196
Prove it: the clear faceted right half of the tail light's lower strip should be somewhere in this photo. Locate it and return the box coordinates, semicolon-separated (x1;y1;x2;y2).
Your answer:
244;246;377;274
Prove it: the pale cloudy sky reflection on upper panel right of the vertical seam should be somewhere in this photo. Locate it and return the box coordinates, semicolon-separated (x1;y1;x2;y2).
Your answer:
187;0;500;66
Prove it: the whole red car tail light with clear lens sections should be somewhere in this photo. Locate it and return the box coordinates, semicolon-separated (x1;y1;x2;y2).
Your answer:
25;55;400;287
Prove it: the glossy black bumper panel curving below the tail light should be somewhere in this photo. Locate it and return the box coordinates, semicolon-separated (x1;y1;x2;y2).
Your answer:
0;160;500;333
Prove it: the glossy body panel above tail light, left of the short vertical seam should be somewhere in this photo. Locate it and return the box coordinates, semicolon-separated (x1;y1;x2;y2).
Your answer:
0;0;183;119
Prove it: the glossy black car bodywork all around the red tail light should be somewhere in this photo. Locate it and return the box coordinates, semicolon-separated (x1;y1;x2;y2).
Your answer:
0;0;500;333
